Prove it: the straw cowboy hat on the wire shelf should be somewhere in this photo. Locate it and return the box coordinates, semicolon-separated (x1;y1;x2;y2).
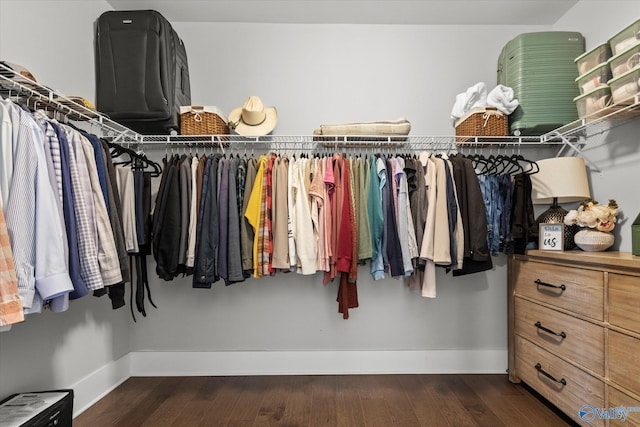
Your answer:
229;96;278;136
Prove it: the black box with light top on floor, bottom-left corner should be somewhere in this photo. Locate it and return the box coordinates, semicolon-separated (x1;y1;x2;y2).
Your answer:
0;389;73;427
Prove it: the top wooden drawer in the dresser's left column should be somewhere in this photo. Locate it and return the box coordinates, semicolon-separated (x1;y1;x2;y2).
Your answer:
513;261;604;321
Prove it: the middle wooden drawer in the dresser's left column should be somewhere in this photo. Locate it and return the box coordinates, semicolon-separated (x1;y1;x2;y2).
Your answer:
515;297;604;375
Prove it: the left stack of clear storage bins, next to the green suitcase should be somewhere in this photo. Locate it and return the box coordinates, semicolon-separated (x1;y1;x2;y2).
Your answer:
574;43;611;119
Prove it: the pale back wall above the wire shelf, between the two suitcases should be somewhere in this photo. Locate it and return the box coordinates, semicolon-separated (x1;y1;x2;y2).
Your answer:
175;23;544;135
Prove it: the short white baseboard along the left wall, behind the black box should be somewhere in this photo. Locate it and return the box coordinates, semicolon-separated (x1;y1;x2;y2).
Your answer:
69;353;131;417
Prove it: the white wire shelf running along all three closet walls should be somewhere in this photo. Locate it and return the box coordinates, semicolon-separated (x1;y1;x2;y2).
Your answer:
0;63;640;157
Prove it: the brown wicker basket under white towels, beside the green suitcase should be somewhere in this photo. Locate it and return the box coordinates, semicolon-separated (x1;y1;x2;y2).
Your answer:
455;107;509;142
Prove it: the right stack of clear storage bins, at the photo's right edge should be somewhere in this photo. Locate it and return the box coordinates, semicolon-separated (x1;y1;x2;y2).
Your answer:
608;19;640;105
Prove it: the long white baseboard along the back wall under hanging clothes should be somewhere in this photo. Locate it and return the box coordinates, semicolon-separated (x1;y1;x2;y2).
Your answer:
129;349;507;376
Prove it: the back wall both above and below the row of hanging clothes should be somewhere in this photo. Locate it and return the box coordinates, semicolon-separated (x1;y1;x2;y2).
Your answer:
131;23;546;372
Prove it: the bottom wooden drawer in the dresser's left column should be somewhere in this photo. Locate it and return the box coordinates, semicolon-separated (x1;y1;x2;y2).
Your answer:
515;336;604;426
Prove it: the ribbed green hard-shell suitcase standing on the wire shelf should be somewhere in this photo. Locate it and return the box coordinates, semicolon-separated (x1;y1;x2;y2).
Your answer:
498;31;584;135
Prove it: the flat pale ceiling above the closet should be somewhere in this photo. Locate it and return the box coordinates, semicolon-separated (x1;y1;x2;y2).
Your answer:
107;0;579;25
